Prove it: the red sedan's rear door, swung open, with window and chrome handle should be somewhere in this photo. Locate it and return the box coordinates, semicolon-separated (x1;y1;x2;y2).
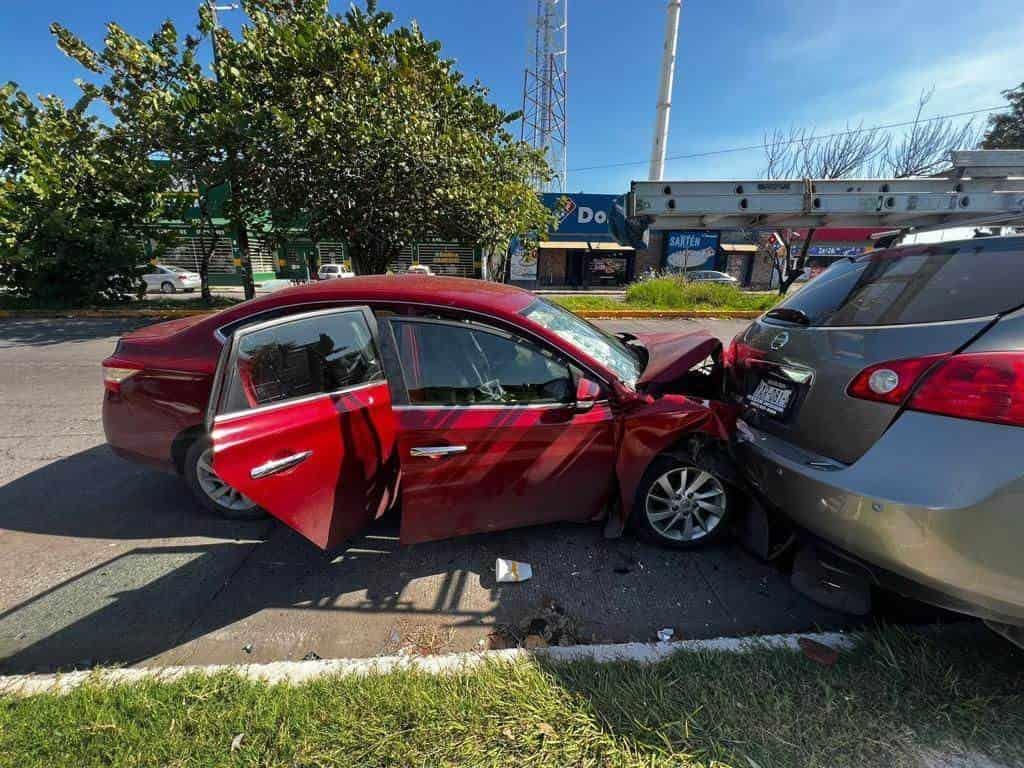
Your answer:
207;307;398;549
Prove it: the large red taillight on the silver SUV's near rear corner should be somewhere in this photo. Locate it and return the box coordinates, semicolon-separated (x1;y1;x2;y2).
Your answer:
847;352;1024;426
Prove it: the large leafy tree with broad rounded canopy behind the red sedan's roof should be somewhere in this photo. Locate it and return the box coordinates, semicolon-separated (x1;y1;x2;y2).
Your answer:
220;0;551;272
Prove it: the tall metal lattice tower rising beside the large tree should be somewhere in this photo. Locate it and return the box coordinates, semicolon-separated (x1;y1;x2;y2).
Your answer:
521;0;568;191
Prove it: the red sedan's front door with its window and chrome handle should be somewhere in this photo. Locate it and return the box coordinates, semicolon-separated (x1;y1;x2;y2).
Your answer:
391;318;614;543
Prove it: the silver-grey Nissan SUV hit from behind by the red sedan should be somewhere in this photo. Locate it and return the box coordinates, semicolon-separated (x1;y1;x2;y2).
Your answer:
727;237;1024;638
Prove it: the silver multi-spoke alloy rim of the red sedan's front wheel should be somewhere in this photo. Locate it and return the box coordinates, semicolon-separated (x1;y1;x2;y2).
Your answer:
644;467;726;542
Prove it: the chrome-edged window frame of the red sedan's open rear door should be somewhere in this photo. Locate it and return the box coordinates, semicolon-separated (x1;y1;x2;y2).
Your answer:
204;304;387;432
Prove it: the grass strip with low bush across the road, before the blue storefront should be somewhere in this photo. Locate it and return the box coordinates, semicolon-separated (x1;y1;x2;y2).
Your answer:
553;276;779;312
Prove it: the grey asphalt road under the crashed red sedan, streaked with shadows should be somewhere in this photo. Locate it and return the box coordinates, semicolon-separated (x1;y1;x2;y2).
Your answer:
0;313;848;673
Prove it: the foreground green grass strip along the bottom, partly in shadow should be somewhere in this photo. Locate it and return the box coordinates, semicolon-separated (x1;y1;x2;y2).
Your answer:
0;631;1024;768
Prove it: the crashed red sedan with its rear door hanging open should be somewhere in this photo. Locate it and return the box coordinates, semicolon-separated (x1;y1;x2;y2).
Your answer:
102;275;735;549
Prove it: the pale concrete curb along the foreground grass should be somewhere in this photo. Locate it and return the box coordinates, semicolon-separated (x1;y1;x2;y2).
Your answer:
0;632;859;696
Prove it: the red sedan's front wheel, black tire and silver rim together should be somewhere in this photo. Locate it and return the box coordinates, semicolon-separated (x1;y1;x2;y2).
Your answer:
631;454;739;550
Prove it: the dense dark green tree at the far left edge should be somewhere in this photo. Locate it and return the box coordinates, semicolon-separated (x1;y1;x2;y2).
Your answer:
0;83;175;305
